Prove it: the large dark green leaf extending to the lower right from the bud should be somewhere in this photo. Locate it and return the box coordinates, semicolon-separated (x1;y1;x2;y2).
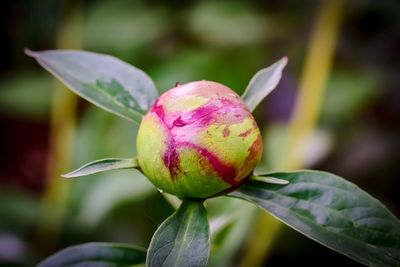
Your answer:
231;171;400;266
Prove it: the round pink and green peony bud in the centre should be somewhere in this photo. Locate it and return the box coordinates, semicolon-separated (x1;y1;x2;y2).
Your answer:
137;81;262;198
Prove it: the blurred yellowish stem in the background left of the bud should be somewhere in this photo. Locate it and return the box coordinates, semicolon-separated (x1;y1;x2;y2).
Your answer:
37;1;82;254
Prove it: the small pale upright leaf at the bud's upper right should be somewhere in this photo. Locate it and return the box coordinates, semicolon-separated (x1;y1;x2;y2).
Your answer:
242;57;287;111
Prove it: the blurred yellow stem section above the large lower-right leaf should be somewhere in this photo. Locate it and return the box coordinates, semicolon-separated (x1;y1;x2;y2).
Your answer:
281;0;343;169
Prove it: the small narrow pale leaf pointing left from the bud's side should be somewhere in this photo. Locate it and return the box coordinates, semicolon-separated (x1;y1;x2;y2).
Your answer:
61;158;139;178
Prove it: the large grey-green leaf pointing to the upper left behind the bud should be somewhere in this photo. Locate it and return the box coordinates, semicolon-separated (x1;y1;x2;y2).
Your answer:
25;49;157;124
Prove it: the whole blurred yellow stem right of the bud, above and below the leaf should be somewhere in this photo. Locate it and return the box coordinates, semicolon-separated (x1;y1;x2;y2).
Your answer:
240;0;343;267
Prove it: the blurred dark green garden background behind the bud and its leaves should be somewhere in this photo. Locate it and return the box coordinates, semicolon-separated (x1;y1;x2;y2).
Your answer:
0;0;400;266
